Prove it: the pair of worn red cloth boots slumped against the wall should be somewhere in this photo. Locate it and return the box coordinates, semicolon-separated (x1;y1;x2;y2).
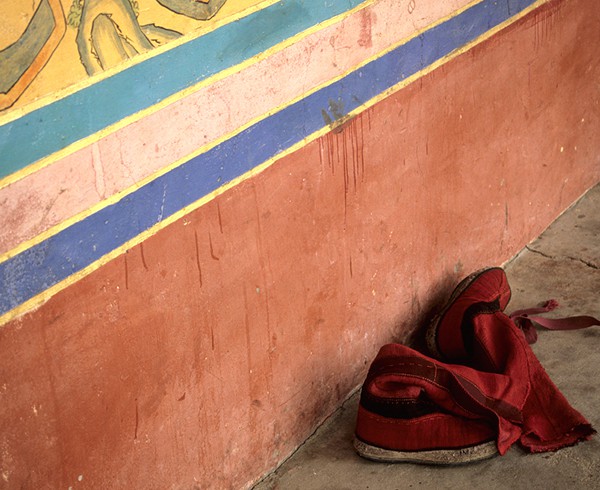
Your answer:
354;268;599;464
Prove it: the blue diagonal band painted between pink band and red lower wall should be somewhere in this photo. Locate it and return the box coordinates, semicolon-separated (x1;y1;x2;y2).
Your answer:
0;0;534;314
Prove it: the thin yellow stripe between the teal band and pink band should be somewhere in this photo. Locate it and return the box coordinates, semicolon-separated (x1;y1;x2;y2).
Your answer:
0;0;377;189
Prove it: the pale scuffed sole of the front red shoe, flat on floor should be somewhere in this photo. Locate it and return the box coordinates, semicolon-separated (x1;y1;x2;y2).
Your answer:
354;437;499;465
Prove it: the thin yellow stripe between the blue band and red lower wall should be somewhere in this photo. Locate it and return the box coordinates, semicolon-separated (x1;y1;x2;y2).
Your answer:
0;0;550;327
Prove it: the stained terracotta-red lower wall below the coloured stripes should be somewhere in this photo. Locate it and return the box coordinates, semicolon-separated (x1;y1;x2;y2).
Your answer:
0;0;600;488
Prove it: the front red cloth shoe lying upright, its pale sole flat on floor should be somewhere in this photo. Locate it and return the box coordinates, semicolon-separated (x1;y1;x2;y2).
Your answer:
354;344;498;464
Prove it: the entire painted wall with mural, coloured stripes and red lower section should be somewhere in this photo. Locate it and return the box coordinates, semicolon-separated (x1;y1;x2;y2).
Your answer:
0;0;600;488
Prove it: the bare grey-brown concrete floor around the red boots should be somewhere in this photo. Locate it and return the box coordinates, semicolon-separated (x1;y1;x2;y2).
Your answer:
255;185;600;490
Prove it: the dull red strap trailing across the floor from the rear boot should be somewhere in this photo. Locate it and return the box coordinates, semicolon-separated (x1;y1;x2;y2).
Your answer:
509;299;600;344
